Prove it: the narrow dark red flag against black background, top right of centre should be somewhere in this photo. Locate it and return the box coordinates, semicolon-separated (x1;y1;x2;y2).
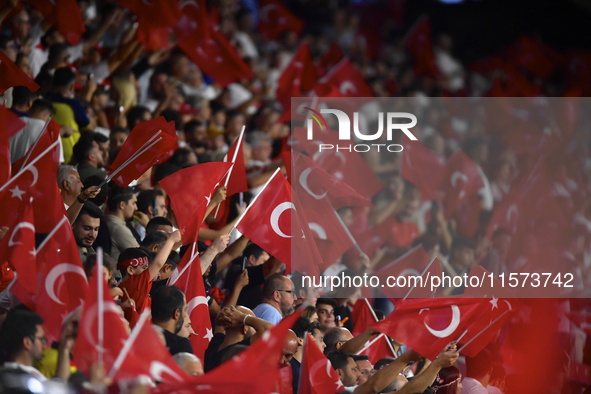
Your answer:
404;16;441;78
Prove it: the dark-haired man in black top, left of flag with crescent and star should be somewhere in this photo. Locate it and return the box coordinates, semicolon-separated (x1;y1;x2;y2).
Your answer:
152;286;193;356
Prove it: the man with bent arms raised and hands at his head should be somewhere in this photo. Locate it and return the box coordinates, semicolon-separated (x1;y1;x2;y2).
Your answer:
204;306;273;372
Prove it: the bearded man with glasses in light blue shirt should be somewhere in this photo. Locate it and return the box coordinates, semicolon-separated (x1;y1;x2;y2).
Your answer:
253;273;297;325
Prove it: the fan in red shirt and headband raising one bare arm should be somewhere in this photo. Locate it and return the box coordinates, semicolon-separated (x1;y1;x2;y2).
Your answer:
117;231;181;317
